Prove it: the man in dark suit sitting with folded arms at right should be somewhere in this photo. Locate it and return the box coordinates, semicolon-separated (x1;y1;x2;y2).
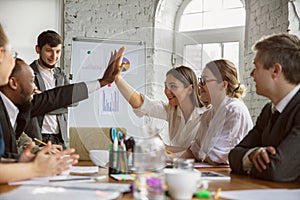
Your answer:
229;34;300;182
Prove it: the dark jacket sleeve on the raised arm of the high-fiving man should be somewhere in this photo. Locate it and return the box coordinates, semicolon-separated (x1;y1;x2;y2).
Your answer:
31;82;88;117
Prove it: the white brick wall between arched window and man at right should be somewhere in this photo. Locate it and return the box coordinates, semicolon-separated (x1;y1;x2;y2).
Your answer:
243;0;289;122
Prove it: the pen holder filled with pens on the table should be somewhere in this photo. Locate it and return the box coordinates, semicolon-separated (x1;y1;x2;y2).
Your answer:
108;150;129;175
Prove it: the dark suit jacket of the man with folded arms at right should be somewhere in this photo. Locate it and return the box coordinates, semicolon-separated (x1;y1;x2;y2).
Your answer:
229;90;300;181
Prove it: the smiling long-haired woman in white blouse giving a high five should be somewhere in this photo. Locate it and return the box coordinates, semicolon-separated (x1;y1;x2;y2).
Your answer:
115;66;205;148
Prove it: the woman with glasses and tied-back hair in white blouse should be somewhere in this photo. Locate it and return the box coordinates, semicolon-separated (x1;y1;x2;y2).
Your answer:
176;59;253;165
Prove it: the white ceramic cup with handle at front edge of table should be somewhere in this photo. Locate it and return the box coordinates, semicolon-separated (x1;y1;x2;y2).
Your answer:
165;169;208;200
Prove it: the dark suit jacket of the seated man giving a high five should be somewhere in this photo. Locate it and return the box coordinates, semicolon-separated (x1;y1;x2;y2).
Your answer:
0;83;88;158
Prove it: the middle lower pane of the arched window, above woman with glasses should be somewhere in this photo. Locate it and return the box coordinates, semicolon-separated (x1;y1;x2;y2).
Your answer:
202;43;222;68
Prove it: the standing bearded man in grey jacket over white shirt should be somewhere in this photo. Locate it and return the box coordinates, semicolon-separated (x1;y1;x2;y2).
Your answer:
25;30;69;149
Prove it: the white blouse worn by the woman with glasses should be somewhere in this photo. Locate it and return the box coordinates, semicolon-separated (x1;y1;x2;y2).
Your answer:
190;96;253;164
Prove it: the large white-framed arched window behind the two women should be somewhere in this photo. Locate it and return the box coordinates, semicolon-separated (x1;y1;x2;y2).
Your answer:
174;0;245;76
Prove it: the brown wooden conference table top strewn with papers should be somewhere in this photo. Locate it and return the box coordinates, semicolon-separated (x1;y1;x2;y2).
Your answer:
0;161;300;200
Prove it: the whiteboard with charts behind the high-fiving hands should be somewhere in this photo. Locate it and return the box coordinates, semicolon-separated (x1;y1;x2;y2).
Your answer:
68;38;146;136
